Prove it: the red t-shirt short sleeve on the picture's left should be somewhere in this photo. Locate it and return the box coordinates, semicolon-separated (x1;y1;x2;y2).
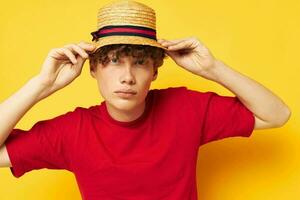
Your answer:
5;108;80;178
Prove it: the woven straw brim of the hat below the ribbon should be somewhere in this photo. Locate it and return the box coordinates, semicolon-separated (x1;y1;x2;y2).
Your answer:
93;35;167;52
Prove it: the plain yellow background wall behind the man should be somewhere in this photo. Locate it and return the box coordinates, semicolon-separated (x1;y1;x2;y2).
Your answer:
0;0;300;200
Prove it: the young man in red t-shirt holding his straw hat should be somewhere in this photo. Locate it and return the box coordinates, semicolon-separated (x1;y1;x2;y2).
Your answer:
0;1;291;200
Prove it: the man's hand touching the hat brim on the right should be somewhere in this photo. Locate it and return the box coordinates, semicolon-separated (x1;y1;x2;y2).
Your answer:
158;37;216;80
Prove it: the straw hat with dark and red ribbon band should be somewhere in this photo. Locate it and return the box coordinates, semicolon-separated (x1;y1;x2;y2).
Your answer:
91;0;166;51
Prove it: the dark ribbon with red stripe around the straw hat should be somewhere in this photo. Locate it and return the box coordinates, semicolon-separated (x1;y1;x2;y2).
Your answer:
91;25;156;41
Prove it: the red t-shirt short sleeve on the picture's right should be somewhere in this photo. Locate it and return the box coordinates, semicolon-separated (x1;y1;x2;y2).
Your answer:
187;87;255;146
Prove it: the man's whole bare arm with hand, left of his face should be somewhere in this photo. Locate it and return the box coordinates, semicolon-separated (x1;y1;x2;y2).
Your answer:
0;42;94;166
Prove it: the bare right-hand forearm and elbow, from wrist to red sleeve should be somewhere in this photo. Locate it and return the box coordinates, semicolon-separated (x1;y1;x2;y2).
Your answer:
211;60;291;129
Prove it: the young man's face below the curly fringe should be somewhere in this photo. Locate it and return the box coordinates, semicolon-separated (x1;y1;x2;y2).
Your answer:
91;52;157;111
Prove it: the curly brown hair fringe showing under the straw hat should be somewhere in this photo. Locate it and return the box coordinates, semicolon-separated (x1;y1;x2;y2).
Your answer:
89;44;168;71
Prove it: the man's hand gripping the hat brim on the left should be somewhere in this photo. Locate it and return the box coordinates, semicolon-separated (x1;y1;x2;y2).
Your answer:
38;42;95;92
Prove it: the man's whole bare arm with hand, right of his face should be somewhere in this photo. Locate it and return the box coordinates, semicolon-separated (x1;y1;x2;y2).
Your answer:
158;37;291;129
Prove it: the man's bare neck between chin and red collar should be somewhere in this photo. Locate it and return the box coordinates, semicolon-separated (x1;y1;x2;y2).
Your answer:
105;101;146;122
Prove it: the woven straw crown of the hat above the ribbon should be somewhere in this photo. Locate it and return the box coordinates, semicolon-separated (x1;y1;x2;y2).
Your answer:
97;0;156;30
